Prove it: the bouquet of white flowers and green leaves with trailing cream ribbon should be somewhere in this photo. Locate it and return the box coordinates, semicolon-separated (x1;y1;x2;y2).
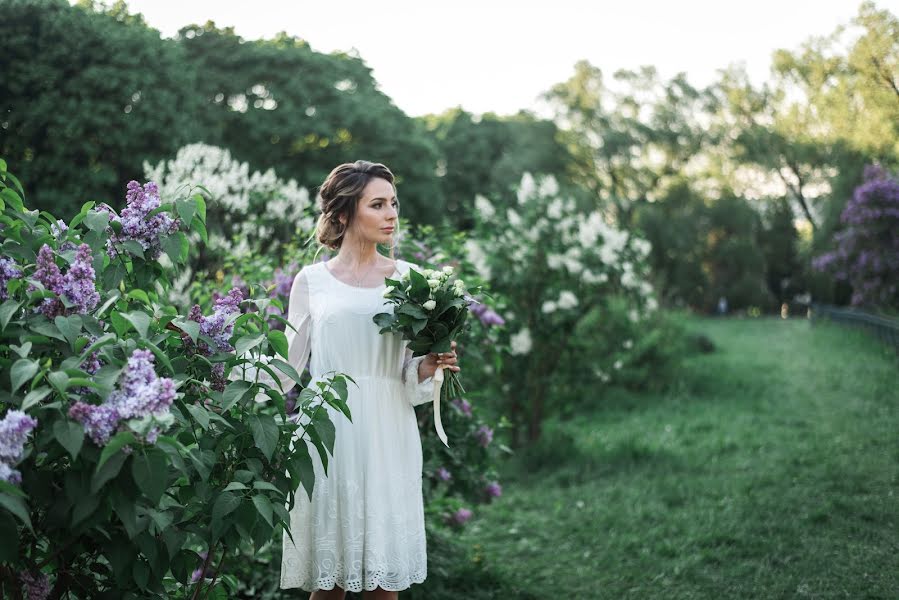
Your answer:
374;266;469;447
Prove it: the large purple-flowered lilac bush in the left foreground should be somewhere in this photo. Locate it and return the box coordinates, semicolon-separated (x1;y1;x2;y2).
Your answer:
0;160;350;598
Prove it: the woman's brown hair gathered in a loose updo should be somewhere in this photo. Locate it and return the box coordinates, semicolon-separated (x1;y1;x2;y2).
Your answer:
315;160;396;250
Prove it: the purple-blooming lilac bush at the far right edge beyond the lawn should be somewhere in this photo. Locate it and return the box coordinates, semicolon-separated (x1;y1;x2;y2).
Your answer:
812;166;899;308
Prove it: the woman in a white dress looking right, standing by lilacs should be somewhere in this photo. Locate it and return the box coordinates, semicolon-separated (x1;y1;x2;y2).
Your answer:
246;160;459;600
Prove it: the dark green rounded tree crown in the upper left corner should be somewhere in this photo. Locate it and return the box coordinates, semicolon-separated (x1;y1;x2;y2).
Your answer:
0;0;197;214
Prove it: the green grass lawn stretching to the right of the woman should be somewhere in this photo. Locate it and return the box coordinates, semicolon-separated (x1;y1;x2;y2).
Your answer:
461;318;899;599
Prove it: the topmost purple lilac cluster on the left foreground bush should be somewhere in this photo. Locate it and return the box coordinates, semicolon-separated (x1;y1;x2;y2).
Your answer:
98;181;179;260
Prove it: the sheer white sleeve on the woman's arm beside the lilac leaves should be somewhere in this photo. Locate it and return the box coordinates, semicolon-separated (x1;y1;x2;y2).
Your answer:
229;269;312;402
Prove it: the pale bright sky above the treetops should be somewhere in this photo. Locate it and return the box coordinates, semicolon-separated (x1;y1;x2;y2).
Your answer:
103;0;899;116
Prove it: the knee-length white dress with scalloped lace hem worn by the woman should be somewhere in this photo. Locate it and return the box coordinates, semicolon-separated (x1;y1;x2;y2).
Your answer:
251;261;434;592
